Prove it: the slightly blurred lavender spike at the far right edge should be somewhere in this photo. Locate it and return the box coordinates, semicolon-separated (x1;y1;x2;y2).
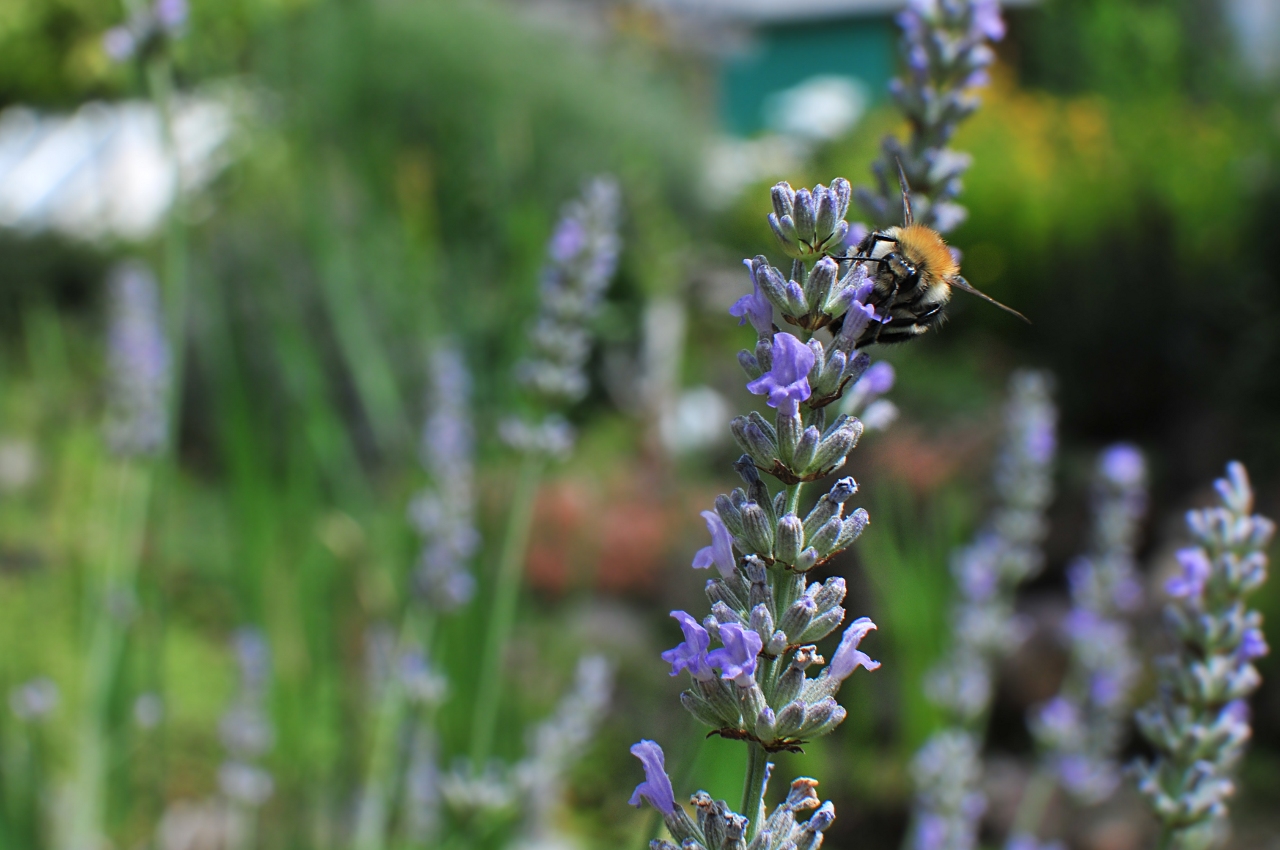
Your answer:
1134;462;1275;850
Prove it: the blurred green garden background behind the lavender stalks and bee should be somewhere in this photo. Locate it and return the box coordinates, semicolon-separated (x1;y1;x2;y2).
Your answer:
0;0;1280;850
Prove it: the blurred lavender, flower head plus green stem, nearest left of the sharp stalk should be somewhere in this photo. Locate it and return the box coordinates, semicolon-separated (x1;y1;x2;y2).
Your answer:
471;177;621;771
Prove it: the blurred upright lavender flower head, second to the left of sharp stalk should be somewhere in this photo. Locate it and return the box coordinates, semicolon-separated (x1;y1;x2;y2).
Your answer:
410;343;480;611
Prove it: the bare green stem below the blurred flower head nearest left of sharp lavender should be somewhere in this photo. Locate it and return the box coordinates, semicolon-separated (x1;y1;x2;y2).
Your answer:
471;452;543;771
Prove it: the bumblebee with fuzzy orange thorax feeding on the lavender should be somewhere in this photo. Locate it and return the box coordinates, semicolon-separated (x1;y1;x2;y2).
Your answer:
833;171;1030;348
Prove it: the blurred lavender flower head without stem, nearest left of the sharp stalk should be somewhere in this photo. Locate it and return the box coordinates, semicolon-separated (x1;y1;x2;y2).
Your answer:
502;177;622;454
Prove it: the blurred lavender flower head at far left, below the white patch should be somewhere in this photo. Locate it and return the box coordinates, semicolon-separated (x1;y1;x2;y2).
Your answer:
106;260;173;456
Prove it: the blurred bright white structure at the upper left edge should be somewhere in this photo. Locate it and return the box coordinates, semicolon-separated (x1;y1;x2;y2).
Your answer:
0;97;232;241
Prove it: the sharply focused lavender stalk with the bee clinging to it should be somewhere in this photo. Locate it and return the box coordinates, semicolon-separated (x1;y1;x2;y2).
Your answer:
631;171;891;850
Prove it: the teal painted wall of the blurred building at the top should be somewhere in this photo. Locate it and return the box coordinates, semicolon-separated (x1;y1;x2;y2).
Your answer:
719;15;897;136
